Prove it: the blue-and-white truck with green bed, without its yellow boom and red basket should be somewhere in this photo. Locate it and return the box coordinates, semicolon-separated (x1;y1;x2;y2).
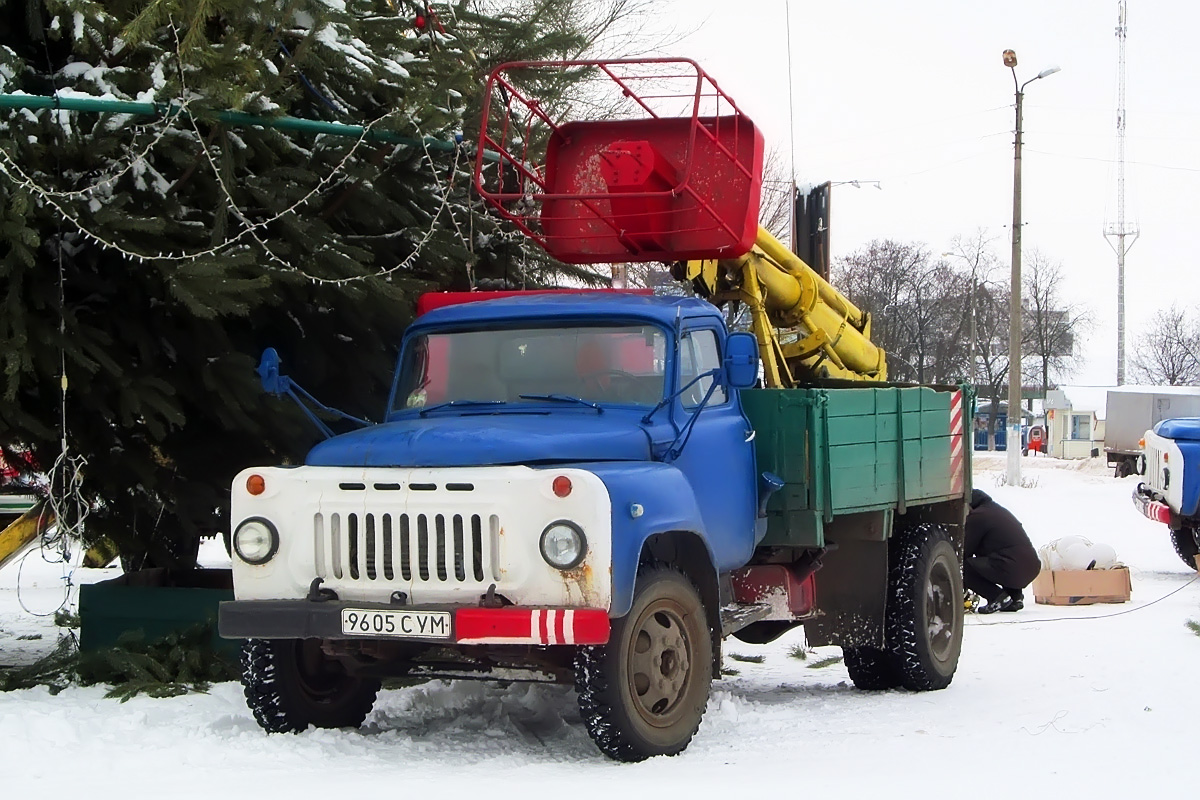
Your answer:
220;294;970;760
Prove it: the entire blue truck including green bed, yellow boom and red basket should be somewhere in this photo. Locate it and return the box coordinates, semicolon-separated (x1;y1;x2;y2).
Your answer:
220;60;971;760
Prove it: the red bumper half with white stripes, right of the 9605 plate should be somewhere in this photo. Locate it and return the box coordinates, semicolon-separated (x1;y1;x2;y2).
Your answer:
454;606;608;644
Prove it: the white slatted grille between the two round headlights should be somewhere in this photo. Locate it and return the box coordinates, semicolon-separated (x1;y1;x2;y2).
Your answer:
313;512;500;585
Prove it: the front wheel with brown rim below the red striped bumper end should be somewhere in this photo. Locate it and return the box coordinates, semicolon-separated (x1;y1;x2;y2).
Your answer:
575;567;713;762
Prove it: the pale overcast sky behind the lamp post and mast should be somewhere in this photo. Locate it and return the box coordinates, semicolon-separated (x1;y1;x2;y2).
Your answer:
662;0;1200;385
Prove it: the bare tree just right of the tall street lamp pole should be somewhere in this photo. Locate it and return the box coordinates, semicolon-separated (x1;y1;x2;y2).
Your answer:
1021;249;1091;391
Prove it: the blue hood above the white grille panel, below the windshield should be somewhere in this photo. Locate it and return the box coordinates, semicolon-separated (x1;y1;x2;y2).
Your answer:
306;410;650;467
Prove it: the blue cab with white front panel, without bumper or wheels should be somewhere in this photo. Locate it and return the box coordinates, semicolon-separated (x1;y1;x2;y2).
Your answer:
227;295;758;632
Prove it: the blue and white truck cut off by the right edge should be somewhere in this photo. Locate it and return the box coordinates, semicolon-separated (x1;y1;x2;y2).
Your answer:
1133;417;1200;570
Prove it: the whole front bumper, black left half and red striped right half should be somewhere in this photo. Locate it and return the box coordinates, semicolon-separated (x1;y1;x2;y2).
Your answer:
217;600;610;645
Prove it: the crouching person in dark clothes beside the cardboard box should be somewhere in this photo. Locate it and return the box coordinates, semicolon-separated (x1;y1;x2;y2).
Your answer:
962;489;1042;614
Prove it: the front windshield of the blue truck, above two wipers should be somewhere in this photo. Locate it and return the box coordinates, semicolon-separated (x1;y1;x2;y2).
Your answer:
391;325;666;411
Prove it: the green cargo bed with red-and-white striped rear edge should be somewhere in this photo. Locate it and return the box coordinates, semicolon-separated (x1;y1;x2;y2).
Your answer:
742;384;971;547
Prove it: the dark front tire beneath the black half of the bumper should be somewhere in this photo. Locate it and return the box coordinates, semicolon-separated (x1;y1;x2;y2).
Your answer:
241;639;379;733
